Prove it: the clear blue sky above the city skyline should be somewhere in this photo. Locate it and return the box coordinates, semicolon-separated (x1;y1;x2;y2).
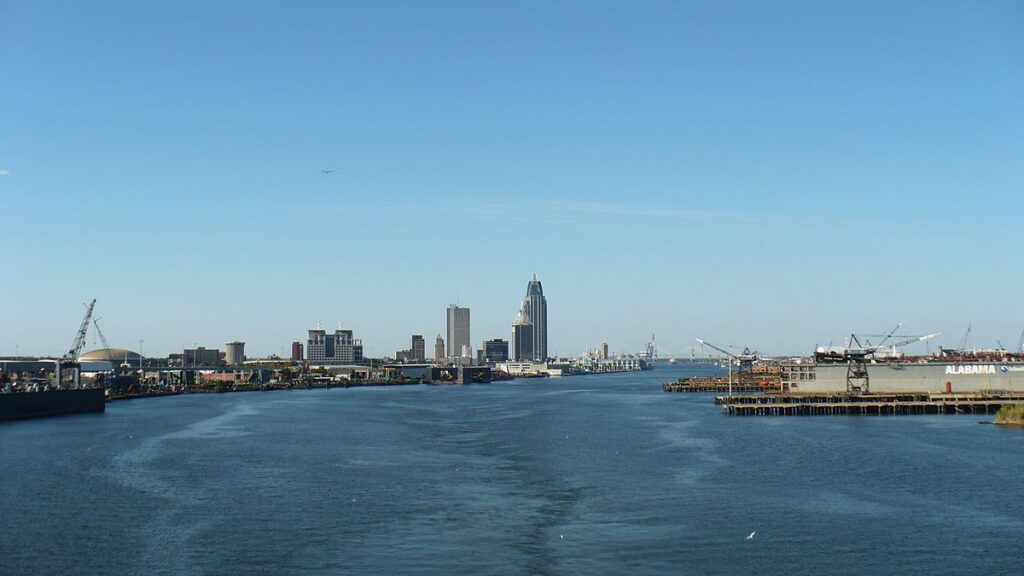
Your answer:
0;0;1024;357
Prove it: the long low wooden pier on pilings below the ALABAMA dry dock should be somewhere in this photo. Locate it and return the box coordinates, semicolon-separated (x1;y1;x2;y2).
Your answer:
715;392;1024;416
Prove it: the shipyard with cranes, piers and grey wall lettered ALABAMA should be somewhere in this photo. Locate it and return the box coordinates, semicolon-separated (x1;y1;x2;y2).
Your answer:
663;323;1024;416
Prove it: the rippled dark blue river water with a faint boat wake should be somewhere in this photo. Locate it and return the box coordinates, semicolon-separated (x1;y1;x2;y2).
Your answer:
0;366;1024;576
